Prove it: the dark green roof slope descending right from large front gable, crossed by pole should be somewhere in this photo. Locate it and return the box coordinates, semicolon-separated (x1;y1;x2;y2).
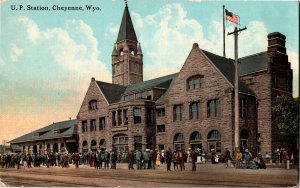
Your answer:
202;50;255;96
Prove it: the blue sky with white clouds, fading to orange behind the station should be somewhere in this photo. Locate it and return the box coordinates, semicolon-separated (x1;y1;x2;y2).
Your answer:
0;0;299;144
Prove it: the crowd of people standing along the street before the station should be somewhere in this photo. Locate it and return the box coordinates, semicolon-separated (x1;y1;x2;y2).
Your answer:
0;148;294;171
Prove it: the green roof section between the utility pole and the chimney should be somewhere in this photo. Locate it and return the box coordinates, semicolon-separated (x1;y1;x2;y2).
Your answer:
239;52;268;75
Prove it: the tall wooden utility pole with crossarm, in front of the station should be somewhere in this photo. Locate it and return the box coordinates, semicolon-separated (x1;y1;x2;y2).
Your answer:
228;27;247;151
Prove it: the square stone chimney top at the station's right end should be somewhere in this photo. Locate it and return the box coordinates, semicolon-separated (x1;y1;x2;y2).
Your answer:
268;32;286;56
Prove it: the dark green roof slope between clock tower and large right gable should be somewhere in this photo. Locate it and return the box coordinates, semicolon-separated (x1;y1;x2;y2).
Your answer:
125;73;178;93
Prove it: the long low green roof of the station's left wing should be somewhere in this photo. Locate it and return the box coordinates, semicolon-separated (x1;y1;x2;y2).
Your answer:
10;119;77;144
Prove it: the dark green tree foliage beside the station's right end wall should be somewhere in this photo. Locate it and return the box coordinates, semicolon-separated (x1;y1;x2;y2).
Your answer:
272;96;299;136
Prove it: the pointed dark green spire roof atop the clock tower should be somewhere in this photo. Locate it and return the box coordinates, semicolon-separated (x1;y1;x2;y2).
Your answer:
117;4;138;42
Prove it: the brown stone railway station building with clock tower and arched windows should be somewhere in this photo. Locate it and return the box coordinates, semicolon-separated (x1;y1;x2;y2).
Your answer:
11;5;293;157
